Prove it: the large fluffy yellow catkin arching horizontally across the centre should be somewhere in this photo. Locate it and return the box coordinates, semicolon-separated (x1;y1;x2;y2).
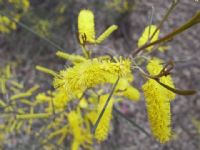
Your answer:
54;58;131;96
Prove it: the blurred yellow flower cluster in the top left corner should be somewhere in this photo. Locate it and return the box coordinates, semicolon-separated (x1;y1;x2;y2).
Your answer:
0;0;30;33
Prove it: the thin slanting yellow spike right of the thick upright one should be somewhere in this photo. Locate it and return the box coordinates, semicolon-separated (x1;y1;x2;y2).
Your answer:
96;25;118;44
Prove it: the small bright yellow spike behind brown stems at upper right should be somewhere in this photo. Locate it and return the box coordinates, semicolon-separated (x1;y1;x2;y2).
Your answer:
138;25;160;52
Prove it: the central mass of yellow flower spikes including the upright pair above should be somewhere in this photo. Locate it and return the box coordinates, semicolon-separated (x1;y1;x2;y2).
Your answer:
33;10;140;149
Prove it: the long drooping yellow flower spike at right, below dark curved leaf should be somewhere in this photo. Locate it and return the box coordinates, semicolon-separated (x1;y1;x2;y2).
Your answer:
142;80;171;143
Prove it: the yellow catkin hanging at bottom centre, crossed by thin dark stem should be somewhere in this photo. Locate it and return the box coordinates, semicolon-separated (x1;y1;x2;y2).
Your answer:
94;94;113;141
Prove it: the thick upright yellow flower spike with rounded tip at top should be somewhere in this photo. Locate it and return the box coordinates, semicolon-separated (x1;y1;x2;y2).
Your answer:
78;9;95;44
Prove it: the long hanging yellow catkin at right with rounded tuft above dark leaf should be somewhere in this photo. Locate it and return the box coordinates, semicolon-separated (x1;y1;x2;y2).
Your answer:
142;59;175;143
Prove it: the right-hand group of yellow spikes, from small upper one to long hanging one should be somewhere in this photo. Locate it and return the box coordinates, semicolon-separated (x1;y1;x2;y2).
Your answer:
138;22;175;143
